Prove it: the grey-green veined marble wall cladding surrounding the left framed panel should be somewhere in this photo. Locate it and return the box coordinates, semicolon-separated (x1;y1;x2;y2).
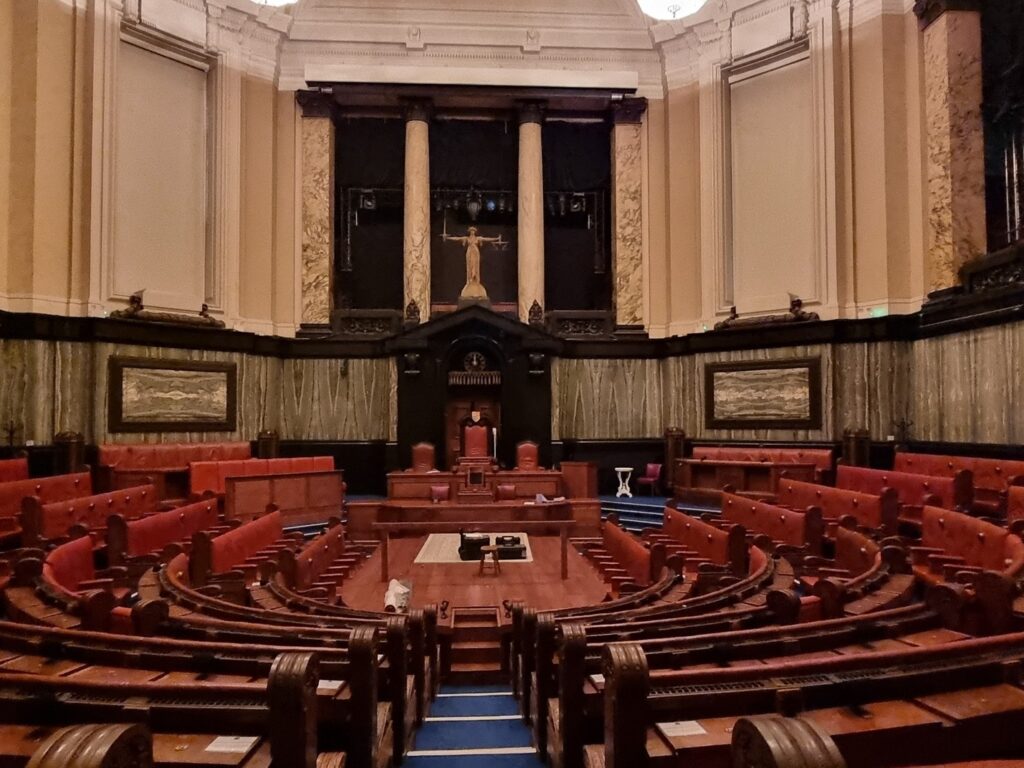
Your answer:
0;339;395;442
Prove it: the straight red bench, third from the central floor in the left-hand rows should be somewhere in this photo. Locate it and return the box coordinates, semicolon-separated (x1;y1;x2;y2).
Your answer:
106;500;219;565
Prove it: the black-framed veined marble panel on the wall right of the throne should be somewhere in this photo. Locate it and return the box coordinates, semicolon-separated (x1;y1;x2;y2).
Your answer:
705;357;821;429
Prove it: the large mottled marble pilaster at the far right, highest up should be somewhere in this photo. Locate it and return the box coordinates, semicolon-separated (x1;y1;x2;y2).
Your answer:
914;0;986;291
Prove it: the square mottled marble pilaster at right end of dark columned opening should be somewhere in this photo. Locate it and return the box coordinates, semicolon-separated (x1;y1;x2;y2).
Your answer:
611;98;647;327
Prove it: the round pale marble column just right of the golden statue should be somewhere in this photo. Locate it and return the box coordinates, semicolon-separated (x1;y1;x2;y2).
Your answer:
517;102;544;323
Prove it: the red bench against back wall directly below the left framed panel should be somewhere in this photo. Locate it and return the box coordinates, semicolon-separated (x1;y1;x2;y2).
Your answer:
98;442;252;499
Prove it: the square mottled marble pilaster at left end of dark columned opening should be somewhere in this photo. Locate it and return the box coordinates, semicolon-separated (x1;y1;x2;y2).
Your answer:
297;91;334;327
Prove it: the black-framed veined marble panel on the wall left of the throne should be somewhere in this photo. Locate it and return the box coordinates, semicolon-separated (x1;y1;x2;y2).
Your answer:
108;356;238;432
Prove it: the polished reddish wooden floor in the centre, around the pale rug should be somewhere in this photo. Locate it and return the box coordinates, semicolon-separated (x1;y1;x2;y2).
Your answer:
341;536;608;610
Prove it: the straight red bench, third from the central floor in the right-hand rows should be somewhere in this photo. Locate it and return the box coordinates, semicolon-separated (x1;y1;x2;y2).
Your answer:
775;478;899;535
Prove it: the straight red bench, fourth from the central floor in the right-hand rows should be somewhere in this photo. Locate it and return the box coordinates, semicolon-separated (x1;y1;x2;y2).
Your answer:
836;465;974;520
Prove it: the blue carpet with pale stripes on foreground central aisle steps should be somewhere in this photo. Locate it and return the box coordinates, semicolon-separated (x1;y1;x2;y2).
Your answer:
404;685;544;768
